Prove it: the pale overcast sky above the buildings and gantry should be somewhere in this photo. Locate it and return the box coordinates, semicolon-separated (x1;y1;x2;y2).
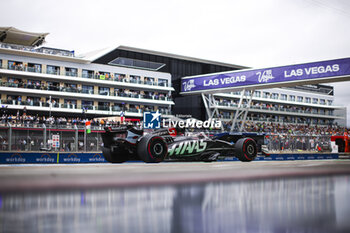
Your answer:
0;0;350;126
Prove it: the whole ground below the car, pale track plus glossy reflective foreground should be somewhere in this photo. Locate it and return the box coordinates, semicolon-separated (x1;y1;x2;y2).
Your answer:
0;160;350;233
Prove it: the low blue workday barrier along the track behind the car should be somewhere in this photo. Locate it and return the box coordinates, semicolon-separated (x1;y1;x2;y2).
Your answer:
0;152;339;164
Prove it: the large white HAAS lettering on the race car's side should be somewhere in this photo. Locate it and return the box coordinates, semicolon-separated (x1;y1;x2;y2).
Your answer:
169;140;207;156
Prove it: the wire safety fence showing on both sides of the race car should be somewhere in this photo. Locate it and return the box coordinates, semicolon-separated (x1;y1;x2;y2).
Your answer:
0;123;331;153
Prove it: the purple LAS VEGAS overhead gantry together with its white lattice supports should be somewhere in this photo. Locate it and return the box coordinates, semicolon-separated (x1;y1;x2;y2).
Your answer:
180;58;350;131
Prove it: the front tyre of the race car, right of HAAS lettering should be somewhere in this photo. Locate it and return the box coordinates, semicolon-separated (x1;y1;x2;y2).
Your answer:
235;138;258;162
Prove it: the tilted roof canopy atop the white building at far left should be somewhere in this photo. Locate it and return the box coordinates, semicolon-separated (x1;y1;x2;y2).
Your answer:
0;27;49;46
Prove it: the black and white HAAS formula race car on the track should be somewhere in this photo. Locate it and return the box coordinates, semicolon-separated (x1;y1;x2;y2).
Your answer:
102;126;266;163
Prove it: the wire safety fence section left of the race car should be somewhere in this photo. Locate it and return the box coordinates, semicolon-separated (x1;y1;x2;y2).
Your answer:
0;124;103;152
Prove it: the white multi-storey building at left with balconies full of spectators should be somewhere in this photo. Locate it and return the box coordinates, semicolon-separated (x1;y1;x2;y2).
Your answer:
0;28;174;119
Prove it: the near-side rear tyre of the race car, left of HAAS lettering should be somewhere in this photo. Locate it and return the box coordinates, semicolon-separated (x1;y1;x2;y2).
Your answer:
137;134;168;163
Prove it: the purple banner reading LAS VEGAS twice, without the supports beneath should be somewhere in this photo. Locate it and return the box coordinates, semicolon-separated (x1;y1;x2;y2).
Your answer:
181;58;350;93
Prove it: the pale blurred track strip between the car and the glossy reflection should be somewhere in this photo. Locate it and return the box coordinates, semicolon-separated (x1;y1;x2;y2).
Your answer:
0;160;350;192
